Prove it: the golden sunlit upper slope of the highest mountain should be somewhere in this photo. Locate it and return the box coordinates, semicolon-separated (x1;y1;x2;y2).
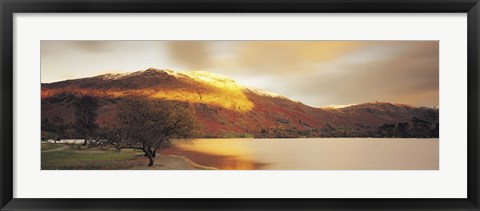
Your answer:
42;68;253;112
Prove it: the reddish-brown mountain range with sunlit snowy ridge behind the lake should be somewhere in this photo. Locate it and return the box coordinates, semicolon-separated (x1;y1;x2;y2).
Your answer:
41;68;439;138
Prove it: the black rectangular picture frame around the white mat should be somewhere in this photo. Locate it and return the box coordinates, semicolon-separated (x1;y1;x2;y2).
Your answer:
0;0;480;210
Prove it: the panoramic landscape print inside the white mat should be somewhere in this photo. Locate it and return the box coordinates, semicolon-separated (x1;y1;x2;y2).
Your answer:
37;40;439;170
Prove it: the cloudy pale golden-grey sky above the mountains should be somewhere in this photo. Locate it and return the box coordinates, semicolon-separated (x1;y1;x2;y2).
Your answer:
41;41;439;107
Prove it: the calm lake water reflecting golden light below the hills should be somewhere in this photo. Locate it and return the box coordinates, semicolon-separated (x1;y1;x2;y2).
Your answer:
164;138;439;170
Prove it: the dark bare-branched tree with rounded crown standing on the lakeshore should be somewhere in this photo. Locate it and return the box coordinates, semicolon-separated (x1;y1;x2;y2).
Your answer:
99;99;196;166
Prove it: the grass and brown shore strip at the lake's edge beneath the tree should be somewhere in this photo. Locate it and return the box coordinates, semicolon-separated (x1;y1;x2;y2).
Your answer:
41;143;208;170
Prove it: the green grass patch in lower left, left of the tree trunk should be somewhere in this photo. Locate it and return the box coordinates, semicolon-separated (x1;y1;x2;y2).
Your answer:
41;144;145;170
